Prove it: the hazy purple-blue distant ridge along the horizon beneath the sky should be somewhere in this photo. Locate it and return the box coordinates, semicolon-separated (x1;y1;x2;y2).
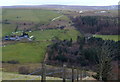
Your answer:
2;5;120;10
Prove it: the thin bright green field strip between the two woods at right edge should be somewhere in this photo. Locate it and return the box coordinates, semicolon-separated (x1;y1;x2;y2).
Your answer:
94;35;120;41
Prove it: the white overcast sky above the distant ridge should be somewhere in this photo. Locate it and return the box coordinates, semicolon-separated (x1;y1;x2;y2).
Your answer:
0;0;119;6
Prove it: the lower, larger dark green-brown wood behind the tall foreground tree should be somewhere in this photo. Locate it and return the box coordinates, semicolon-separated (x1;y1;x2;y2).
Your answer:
48;36;118;72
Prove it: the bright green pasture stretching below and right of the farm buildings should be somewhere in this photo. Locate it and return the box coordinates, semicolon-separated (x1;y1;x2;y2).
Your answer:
2;29;79;63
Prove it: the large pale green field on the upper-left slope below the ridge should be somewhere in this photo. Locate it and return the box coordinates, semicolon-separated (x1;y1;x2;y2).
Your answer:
3;8;68;23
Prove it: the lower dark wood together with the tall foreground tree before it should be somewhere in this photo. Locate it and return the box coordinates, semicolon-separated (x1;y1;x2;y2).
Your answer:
47;36;120;80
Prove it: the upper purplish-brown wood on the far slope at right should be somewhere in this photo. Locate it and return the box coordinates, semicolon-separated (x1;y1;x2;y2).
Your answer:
72;16;120;35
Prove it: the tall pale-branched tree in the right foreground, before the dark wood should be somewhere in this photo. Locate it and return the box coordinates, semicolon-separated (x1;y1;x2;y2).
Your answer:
93;41;114;81
